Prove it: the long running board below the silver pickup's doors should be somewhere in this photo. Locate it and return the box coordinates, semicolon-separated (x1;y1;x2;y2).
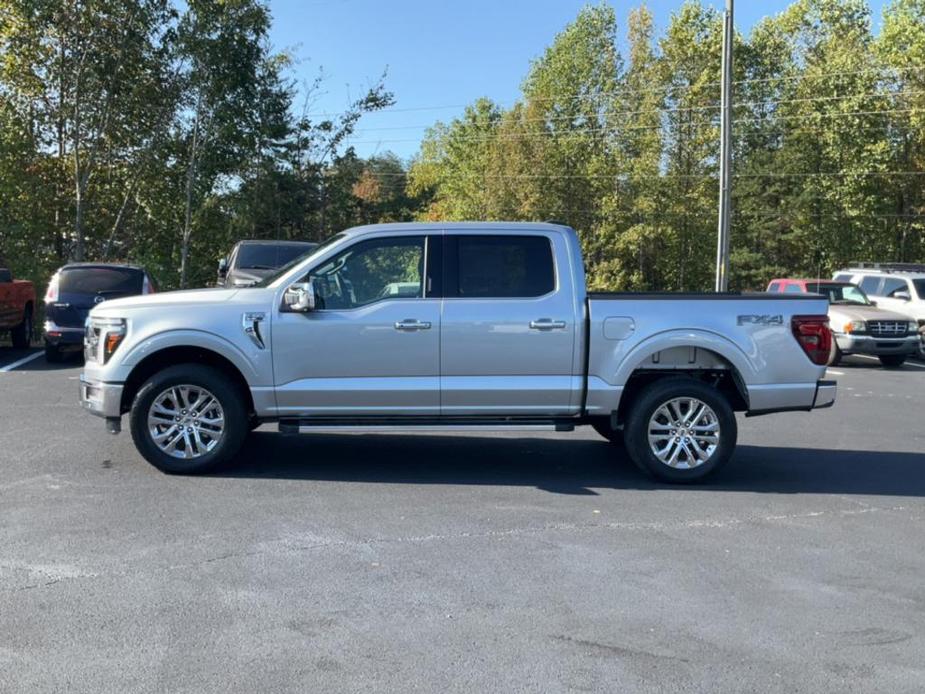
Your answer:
279;417;576;434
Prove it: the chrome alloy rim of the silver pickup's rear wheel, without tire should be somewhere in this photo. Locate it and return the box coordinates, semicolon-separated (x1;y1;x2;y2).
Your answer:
649;398;720;470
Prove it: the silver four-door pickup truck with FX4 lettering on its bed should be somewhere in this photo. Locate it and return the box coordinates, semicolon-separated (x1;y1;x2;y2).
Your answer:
80;223;836;482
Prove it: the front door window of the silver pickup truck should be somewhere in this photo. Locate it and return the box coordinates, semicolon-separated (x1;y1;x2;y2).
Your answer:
309;236;424;310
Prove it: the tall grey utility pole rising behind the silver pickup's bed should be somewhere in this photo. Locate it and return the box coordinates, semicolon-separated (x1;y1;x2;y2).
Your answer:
716;0;735;292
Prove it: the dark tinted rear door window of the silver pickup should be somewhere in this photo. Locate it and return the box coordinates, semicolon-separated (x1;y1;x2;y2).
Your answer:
445;236;556;299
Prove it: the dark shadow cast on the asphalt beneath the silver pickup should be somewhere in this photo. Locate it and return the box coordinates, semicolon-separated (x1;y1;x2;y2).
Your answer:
220;432;925;496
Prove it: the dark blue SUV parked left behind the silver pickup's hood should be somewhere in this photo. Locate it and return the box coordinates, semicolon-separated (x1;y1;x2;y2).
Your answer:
44;263;155;362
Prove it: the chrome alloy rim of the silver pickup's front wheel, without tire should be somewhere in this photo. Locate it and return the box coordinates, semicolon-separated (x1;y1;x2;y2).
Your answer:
148;385;225;460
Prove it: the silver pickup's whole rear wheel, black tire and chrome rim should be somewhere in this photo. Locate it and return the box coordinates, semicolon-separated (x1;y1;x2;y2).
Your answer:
624;377;738;484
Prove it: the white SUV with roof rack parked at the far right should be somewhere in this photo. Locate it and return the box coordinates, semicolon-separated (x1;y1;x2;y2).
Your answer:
834;263;925;357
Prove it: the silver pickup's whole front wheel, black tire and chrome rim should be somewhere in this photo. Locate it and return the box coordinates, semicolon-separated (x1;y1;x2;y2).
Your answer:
130;364;250;474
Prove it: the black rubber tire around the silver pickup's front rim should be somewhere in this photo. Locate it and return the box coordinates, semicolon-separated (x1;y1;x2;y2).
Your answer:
129;364;250;475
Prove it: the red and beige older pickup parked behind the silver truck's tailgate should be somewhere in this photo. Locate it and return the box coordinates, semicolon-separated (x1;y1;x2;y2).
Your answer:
768;279;921;367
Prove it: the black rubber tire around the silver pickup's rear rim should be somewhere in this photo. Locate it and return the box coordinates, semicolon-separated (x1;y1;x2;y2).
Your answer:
623;377;738;484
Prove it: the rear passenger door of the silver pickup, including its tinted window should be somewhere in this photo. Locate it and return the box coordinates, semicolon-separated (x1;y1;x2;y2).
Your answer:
440;234;581;416
